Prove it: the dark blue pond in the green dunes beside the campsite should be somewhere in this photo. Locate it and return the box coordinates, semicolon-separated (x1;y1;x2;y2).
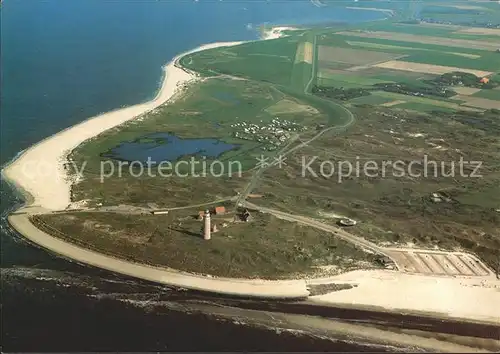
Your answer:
103;133;239;163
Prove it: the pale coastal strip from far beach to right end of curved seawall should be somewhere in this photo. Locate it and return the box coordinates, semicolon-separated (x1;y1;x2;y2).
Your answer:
1;27;309;299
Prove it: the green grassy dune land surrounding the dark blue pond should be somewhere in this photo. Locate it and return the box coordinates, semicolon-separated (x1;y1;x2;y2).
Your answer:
71;74;347;207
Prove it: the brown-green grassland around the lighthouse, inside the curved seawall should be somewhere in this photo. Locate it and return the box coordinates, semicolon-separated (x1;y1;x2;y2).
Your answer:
35;211;375;279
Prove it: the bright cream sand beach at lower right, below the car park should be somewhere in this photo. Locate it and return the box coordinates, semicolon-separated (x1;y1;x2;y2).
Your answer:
308;270;500;323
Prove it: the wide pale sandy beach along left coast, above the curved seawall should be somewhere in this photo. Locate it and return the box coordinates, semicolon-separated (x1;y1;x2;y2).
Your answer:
2;42;242;210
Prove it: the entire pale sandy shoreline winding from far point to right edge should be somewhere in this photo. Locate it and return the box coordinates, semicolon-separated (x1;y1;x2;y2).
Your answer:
2;27;500;321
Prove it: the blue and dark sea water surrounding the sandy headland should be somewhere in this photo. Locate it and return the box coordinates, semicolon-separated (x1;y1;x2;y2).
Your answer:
0;0;394;352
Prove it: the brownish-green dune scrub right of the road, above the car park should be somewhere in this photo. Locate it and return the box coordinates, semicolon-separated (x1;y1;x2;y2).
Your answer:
255;107;500;268
